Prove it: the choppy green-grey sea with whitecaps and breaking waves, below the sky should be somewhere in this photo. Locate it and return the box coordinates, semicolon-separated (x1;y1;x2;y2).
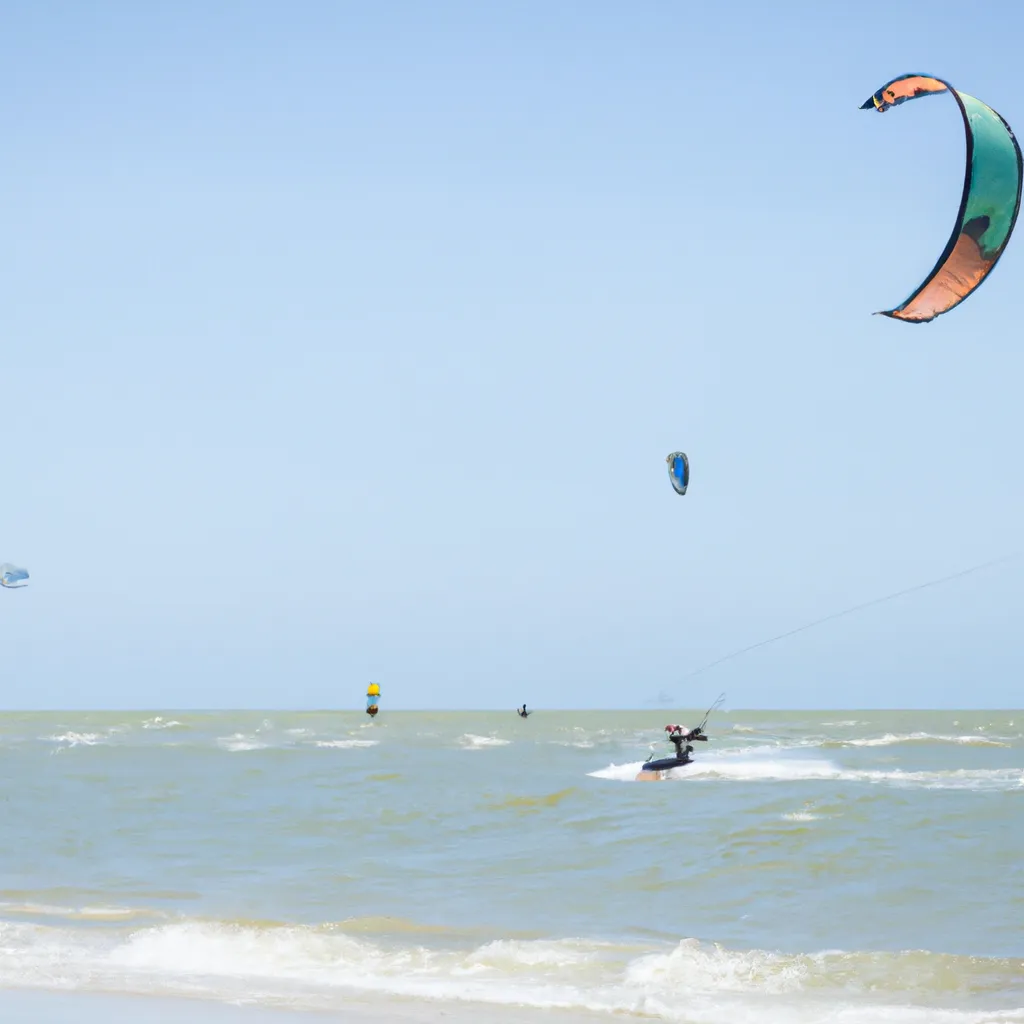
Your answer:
0;712;1024;1024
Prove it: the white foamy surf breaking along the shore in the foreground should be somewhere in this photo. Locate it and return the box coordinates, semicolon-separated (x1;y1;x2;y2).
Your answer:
0;922;1024;1024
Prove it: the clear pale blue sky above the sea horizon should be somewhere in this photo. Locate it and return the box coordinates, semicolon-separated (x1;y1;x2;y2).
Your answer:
0;0;1024;708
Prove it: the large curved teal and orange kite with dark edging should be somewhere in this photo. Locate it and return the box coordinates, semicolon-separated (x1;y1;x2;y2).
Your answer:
860;75;1022;324
